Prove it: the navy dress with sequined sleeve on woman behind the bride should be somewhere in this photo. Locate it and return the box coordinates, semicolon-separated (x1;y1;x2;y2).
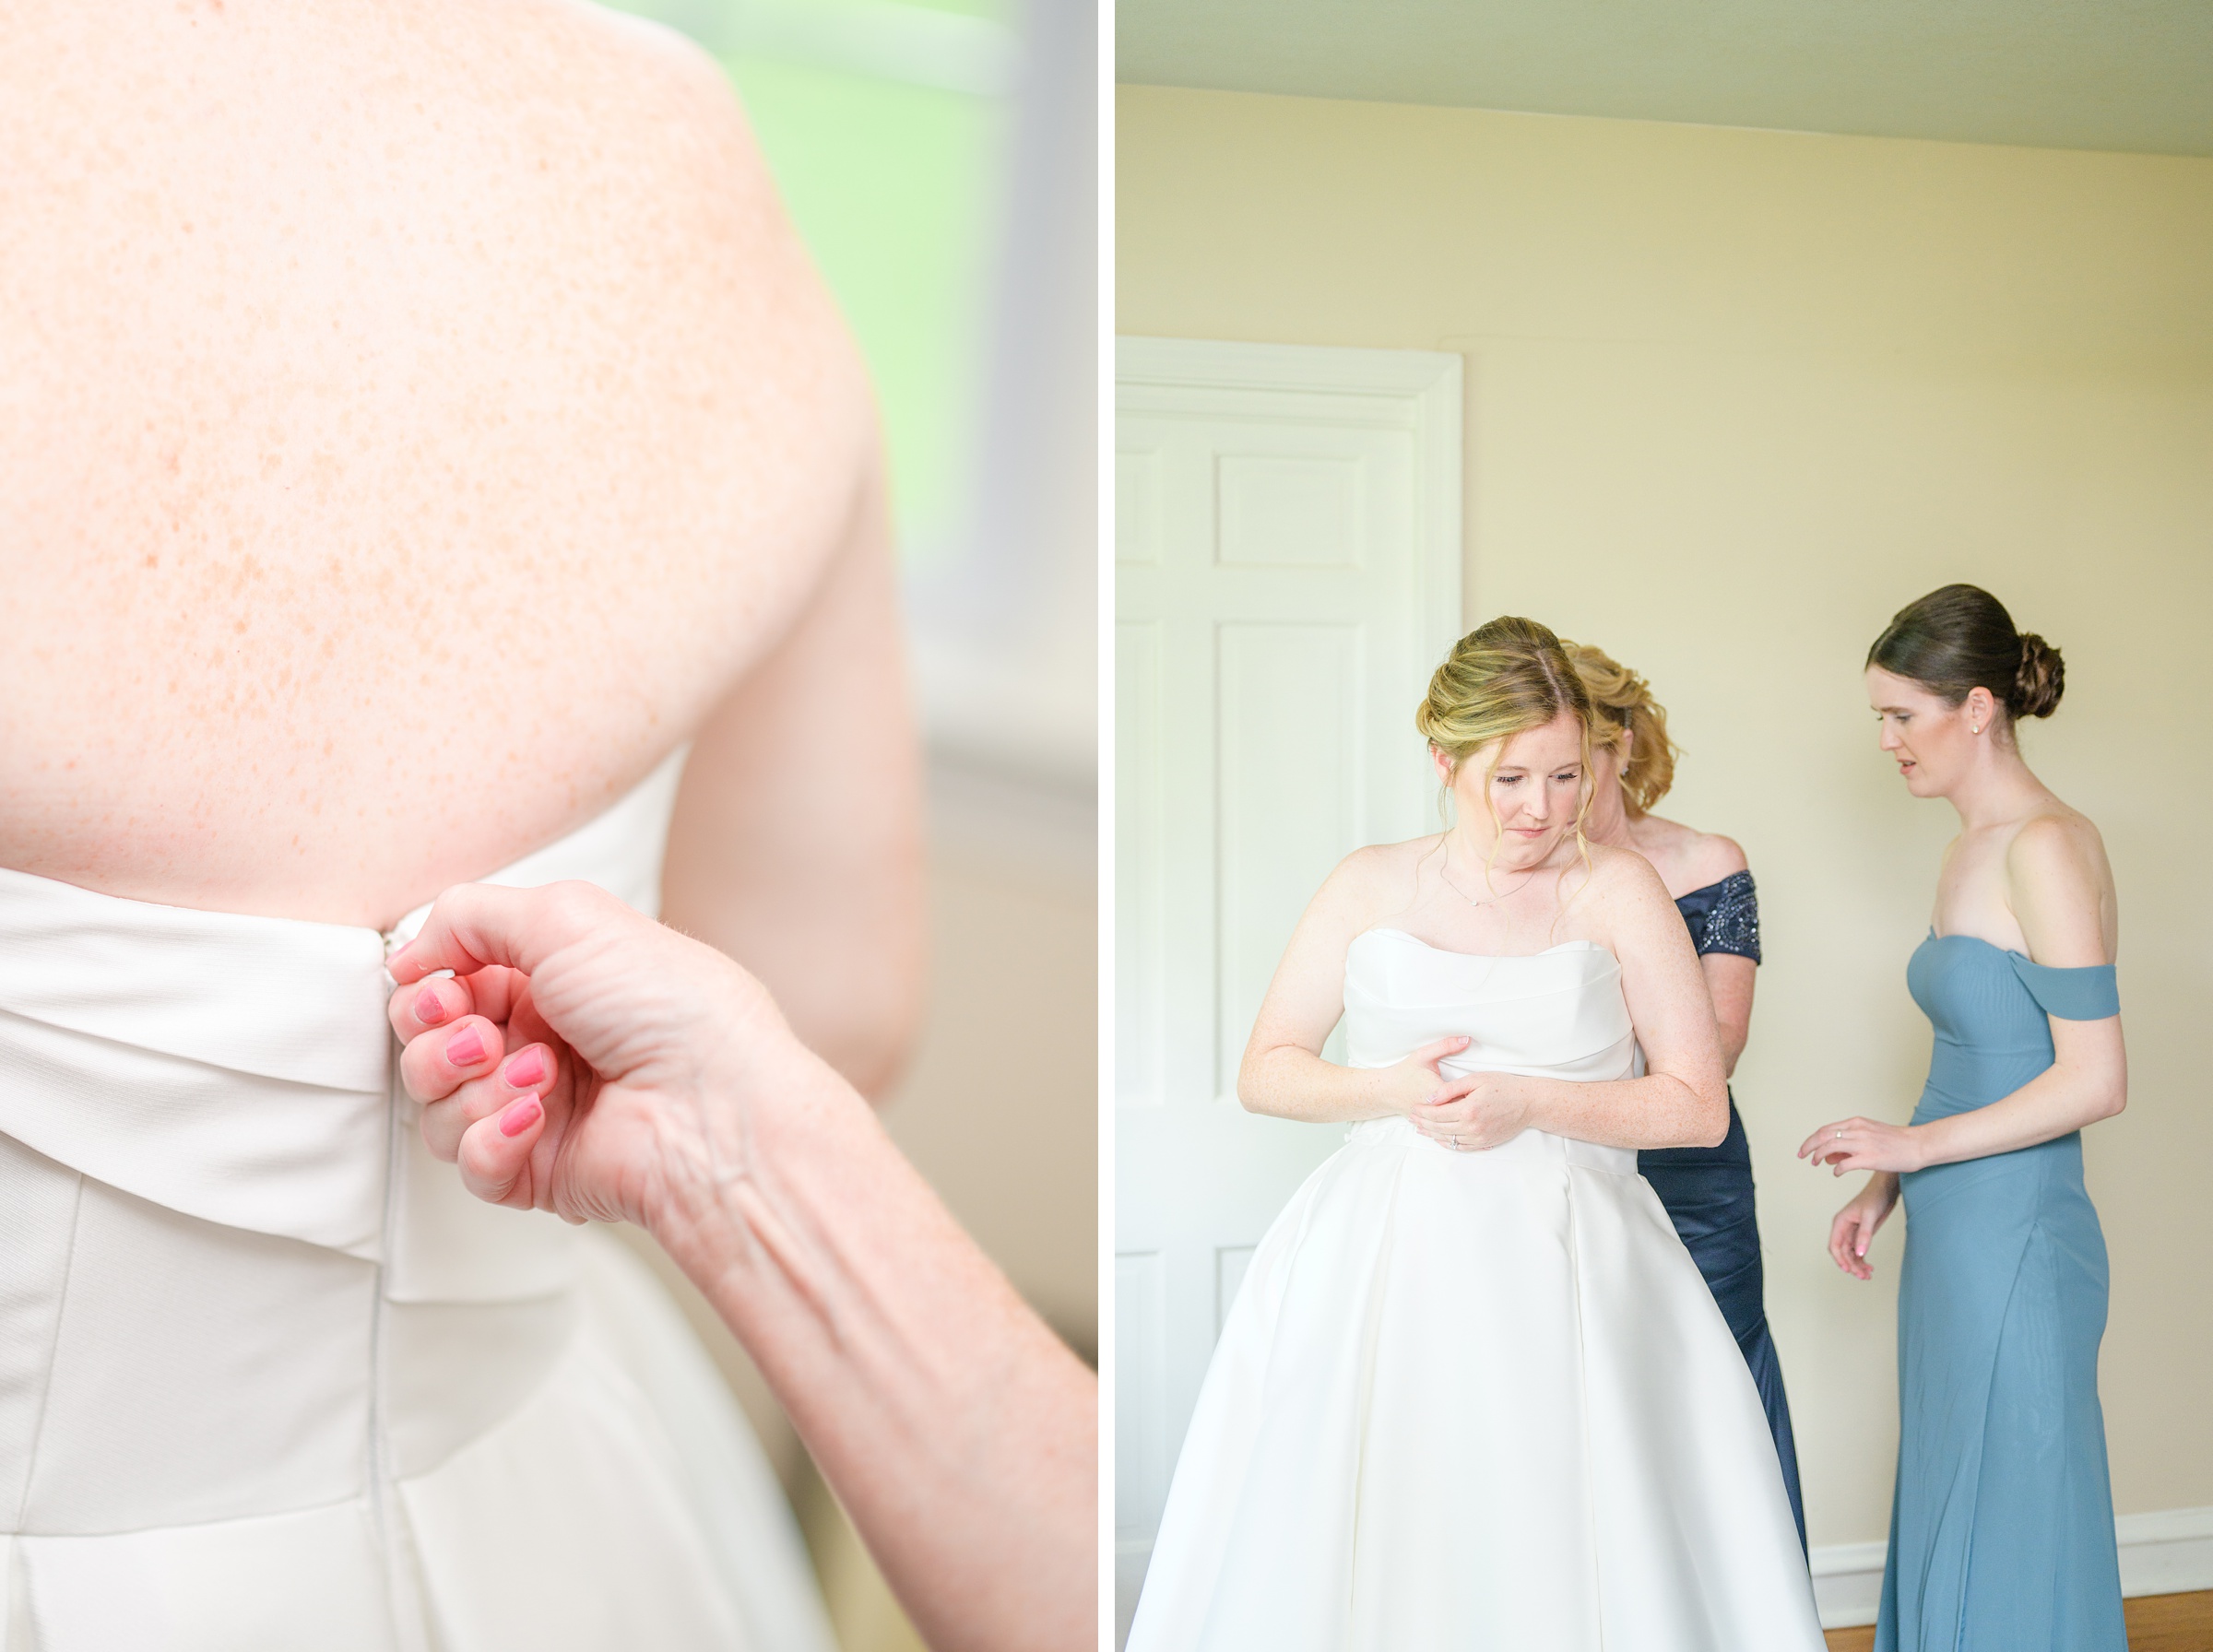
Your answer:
1638;871;1805;1548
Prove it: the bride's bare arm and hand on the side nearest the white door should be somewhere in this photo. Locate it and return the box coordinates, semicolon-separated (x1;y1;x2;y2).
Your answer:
1237;849;1467;1124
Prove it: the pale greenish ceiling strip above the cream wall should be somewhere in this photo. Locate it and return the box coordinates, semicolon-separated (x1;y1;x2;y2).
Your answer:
1116;0;2213;155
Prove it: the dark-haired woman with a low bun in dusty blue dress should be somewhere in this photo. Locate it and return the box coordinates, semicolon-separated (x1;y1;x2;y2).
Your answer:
1799;586;2126;1652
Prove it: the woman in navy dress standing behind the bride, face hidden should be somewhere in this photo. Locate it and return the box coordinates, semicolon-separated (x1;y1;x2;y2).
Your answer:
1567;643;1805;1548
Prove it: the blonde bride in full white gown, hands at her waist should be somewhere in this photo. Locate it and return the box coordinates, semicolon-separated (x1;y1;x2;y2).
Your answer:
1129;620;1824;1652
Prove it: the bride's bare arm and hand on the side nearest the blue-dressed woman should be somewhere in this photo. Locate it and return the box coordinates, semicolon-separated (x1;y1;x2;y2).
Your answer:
1412;852;1728;1148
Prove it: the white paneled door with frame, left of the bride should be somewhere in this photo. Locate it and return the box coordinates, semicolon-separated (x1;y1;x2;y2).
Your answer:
1116;338;1461;1632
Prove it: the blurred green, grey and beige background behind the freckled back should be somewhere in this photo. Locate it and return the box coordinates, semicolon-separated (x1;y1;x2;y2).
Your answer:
615;0;1097;1652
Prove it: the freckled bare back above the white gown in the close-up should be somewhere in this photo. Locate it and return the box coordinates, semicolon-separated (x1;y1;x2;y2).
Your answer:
0;0;896;925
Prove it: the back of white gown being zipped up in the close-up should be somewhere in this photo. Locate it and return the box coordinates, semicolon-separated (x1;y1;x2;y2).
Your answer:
0;754;832;1652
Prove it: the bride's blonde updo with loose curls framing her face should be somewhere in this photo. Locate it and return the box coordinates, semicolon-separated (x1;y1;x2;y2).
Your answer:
1414;615;1595;880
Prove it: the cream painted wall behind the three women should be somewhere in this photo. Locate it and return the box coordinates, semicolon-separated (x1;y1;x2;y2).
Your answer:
1116;87;2213;1543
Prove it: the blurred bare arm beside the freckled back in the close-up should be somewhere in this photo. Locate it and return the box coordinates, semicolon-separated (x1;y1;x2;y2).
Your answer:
662;446;923;1097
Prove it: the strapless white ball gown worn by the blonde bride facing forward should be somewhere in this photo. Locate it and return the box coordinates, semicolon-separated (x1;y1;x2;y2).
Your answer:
1129;929;1824;1652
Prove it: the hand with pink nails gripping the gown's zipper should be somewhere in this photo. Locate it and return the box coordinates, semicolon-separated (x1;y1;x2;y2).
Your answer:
389;882;801;1227
